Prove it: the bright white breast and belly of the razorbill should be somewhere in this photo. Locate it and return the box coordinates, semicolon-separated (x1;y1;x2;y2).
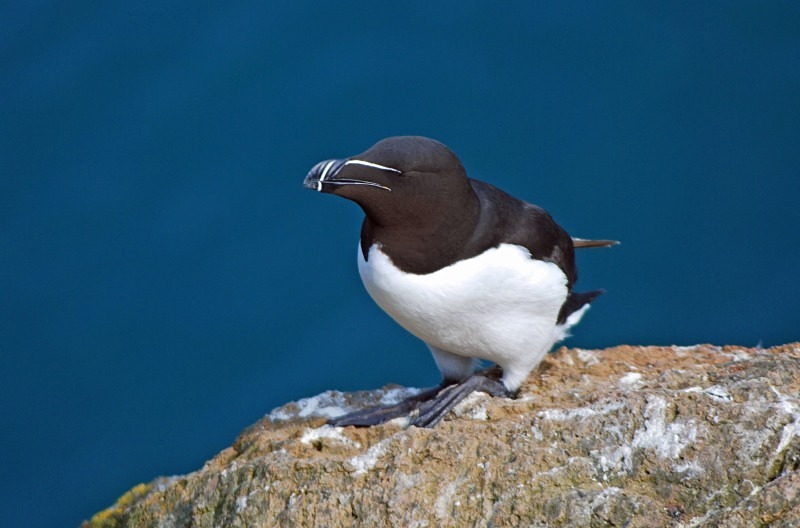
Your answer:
358;244;568;390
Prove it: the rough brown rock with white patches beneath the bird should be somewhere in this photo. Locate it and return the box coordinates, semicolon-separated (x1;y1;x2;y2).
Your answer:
84;343;800;527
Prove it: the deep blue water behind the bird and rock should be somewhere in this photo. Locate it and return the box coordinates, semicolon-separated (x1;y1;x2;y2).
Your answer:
0;0;800;526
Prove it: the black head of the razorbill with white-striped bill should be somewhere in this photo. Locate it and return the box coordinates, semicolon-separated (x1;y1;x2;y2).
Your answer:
303;136;474;227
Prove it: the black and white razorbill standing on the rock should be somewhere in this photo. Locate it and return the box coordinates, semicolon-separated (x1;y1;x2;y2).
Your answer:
303;136;618;427
